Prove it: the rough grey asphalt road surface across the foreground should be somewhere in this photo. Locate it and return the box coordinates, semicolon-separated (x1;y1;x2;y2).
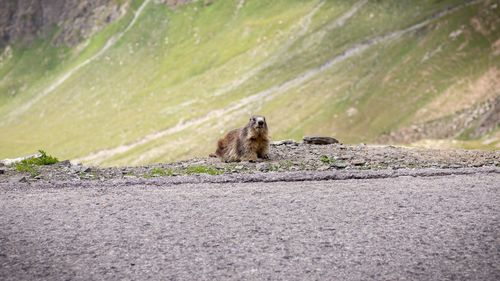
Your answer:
0;167;500;280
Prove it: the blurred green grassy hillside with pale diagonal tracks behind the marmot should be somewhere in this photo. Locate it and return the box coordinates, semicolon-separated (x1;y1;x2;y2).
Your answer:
0;0;500;165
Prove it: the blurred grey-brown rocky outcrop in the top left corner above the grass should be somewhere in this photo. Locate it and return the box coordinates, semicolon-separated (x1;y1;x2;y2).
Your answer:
0;0;127;46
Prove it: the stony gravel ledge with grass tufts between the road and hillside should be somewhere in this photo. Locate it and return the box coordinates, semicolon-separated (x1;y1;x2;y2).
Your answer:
0;141;500;184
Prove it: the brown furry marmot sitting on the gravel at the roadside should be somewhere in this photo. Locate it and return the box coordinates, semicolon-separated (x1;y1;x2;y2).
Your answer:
215;116;269;162
